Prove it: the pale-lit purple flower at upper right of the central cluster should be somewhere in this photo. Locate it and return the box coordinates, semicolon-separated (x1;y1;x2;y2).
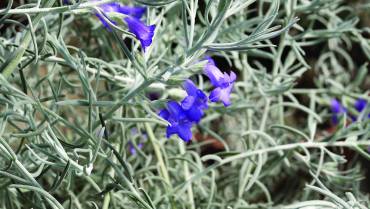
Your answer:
204;57;236;106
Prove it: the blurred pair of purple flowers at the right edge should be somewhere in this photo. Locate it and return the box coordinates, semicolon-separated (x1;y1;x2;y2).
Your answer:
330;99;370;124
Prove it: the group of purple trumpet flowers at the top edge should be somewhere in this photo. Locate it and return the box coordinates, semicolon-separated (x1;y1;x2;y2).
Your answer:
95;2;156;51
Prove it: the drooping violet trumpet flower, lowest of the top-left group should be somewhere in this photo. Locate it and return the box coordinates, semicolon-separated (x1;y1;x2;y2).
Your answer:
124;17;155;51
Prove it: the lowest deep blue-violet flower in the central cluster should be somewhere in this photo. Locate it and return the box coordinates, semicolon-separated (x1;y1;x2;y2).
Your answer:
159;101;192;142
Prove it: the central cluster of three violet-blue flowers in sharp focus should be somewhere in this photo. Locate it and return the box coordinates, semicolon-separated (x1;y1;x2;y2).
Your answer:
159;58;236;142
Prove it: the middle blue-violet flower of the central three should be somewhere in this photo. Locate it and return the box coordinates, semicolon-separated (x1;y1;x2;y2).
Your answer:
181;79;208;123
